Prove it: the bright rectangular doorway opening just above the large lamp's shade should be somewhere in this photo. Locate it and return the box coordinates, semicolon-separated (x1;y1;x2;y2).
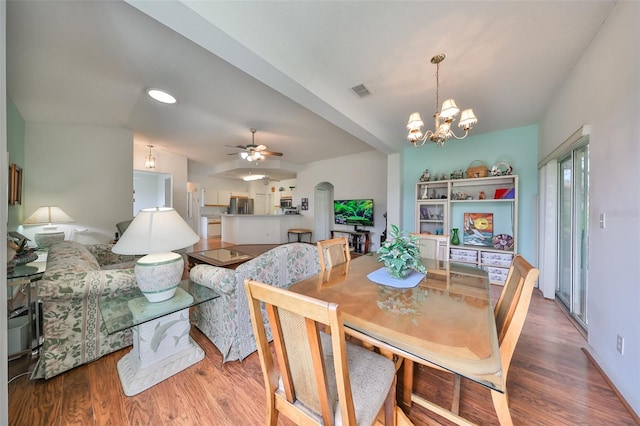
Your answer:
133;170;173;217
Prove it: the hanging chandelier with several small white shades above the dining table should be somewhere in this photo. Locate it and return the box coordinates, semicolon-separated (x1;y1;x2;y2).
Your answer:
407;53;478;147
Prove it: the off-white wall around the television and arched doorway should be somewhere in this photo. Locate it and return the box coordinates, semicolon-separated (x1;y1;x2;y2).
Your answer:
294;151;387;251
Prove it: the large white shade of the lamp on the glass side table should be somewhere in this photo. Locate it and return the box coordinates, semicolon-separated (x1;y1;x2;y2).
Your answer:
112;207;200;254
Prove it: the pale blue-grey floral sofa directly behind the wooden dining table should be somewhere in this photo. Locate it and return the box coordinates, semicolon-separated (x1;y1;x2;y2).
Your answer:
190;243;320;362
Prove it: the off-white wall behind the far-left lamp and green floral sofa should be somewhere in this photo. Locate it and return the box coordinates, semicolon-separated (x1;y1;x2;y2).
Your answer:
21;122;133;244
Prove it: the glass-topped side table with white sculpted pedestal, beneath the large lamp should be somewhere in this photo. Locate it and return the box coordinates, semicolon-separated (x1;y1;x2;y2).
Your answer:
98;279;220;396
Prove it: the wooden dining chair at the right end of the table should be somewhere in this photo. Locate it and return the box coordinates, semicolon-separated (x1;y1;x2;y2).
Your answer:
403;254;539;426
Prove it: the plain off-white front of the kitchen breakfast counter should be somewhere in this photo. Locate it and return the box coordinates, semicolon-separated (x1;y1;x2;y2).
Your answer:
221;214;303;244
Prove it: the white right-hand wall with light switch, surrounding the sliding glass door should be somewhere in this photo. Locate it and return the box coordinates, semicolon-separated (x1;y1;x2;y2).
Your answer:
539;1;640;413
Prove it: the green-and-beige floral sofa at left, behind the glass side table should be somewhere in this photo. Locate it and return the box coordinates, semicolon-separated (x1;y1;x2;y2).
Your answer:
32;241;136;379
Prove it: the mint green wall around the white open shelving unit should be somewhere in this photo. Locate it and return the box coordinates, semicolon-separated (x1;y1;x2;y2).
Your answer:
402;125;538;263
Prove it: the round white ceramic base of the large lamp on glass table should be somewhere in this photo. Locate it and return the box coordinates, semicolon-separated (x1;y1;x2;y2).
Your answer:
134;252;184;302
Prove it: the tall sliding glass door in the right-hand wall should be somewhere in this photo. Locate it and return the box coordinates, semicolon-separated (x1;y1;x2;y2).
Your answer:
556;145;589;331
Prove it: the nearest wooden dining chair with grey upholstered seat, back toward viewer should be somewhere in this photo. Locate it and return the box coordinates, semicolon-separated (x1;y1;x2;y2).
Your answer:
244;279;396;426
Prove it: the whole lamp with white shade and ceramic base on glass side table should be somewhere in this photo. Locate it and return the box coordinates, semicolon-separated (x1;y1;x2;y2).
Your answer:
111;207;200;302
